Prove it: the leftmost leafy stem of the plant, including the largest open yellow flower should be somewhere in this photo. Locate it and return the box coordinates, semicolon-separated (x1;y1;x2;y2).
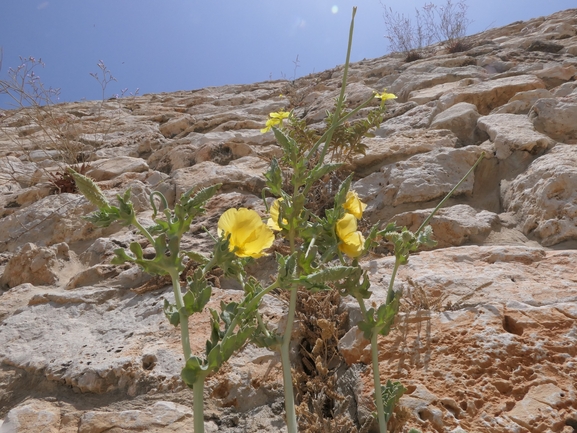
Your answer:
69;170;278;433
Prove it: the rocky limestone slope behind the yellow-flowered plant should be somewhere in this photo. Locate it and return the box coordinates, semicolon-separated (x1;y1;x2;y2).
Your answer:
0;9;577;433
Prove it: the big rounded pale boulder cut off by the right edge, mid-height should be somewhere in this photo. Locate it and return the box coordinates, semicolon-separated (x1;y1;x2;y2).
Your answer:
503;144;577;246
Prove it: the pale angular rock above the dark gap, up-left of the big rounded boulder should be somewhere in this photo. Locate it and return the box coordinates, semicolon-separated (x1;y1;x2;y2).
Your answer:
477;114;555;159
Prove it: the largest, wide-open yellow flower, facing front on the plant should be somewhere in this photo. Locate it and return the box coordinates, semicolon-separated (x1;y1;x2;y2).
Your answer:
218;208;274;259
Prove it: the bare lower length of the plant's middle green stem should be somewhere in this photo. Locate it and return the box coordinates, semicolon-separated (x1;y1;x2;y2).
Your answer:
280;285;298;433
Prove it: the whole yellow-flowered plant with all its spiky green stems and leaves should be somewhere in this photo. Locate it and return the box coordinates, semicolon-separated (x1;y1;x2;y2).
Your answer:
71;7;480;433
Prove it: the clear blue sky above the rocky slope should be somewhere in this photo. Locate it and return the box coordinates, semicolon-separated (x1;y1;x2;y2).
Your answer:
0;0;577;108
